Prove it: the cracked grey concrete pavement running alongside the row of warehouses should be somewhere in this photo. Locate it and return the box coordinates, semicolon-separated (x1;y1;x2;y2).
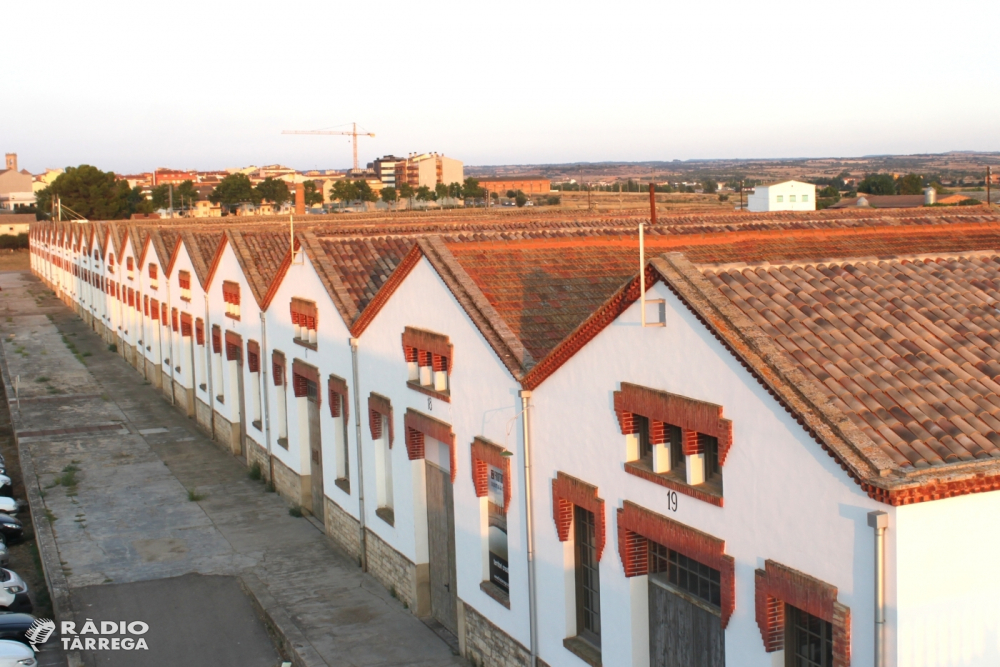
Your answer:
0;273;466;666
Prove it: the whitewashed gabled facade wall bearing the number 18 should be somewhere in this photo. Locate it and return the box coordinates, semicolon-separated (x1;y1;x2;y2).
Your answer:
359;258;529;646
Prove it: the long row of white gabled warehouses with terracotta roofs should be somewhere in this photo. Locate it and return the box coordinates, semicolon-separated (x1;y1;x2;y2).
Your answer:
30;209;1000;667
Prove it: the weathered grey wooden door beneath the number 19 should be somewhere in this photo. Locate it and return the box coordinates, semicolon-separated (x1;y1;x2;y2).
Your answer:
649;574;726;667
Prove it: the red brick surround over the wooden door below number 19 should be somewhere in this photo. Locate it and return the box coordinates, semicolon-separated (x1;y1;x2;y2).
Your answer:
618;500;736;629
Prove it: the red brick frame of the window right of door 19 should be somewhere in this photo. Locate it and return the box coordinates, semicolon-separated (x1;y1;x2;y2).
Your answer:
754;560;851;667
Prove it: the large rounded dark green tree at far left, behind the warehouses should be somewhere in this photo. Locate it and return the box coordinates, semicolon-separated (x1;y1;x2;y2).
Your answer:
36;164;132;220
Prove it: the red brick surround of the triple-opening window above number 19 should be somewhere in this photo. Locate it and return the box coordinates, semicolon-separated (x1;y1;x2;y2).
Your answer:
614;382;733;507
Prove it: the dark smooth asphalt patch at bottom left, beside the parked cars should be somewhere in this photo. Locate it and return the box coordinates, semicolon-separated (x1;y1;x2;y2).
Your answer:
73;574;280;667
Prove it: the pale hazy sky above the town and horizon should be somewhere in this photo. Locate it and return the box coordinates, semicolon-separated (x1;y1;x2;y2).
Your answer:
0;0;1000;172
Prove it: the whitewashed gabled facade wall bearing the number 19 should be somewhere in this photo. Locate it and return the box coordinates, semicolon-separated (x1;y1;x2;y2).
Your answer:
532;284;895;667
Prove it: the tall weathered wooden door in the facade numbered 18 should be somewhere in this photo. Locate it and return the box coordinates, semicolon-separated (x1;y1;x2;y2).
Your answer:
426;461;458;634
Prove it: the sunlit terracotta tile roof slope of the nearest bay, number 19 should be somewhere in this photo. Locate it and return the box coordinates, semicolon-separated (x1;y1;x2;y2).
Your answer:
706;252;1000;468
